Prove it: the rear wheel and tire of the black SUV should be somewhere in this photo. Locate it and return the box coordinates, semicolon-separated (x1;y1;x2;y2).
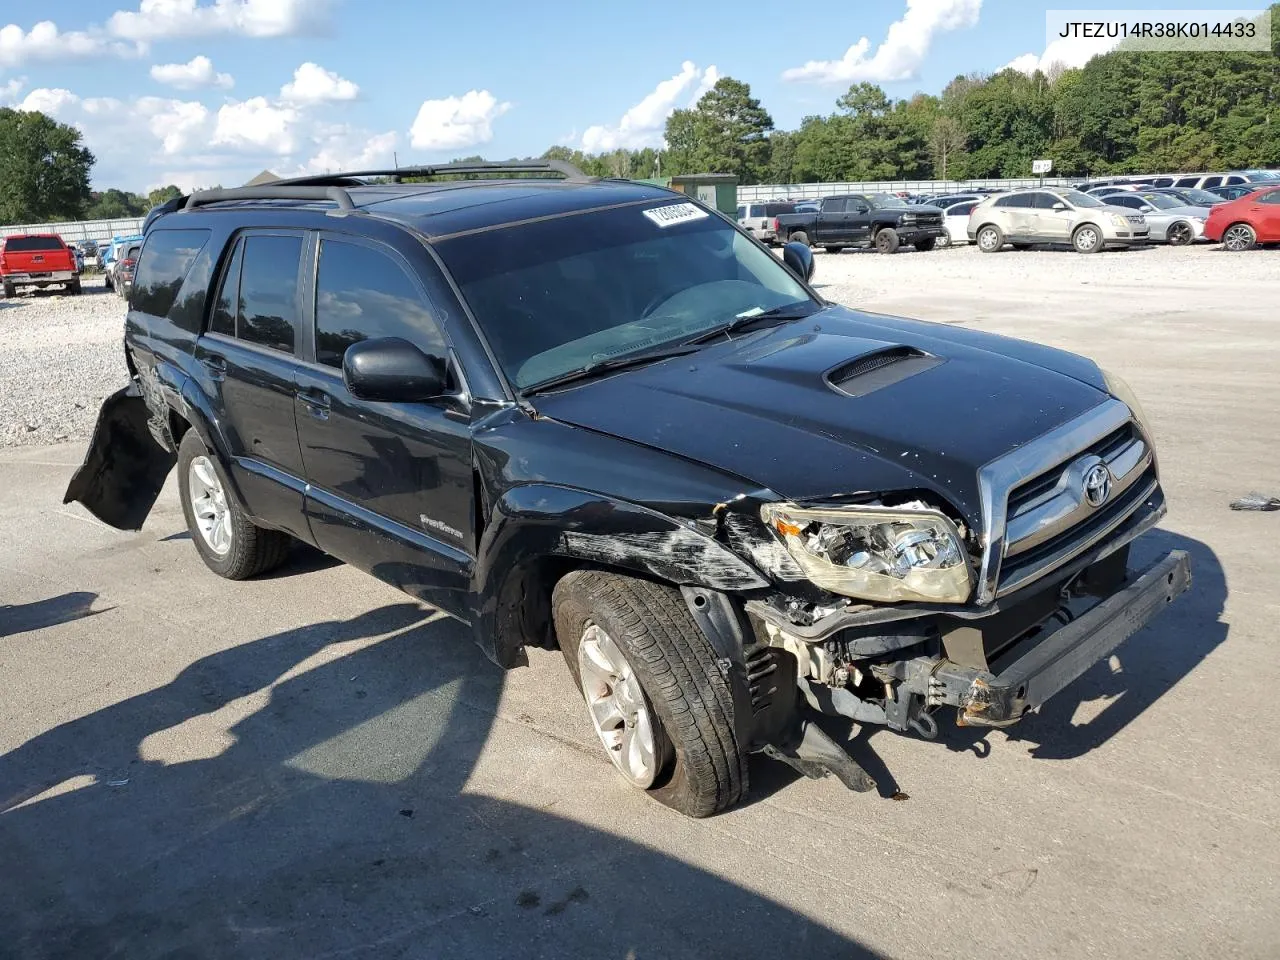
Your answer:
178;430;293;580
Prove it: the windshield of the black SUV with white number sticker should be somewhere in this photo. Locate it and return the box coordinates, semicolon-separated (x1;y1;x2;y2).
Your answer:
436;201;819;389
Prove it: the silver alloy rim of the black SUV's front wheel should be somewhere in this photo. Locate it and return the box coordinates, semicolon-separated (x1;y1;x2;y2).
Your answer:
577;623;658;788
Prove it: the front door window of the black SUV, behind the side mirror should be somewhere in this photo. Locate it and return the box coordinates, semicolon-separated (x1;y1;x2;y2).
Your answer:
316;239;444;367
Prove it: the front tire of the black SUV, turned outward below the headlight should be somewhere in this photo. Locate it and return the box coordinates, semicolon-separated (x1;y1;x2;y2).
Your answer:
552;570;748;817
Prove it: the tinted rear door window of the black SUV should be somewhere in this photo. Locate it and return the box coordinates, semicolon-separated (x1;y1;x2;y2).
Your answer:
236;236;302;353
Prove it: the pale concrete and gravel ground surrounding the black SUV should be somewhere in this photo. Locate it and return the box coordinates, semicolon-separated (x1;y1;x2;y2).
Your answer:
0;240;1280;960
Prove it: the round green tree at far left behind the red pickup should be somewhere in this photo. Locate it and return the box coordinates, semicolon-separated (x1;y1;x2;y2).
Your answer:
0;108;93;224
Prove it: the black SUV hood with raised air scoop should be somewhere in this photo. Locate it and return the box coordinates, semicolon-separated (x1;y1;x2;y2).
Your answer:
534;306;1105;526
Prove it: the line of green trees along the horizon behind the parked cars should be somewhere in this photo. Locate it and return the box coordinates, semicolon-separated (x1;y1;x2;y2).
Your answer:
0;4;1280;224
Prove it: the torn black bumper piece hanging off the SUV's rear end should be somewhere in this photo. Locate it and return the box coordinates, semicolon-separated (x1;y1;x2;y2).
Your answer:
63;381;177;530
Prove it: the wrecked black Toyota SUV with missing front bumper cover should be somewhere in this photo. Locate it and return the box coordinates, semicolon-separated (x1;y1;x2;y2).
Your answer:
67;164;1189;815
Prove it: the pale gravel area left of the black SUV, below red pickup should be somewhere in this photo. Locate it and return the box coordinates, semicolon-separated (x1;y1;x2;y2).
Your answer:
0;278;128;447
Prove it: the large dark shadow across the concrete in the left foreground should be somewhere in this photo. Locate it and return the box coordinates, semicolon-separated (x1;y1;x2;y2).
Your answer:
0;603;874;960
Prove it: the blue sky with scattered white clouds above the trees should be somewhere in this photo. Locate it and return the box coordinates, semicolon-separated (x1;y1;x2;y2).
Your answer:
0;0;1223;191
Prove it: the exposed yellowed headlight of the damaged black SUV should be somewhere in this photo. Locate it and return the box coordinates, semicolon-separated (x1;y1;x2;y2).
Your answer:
760;503;973;603
